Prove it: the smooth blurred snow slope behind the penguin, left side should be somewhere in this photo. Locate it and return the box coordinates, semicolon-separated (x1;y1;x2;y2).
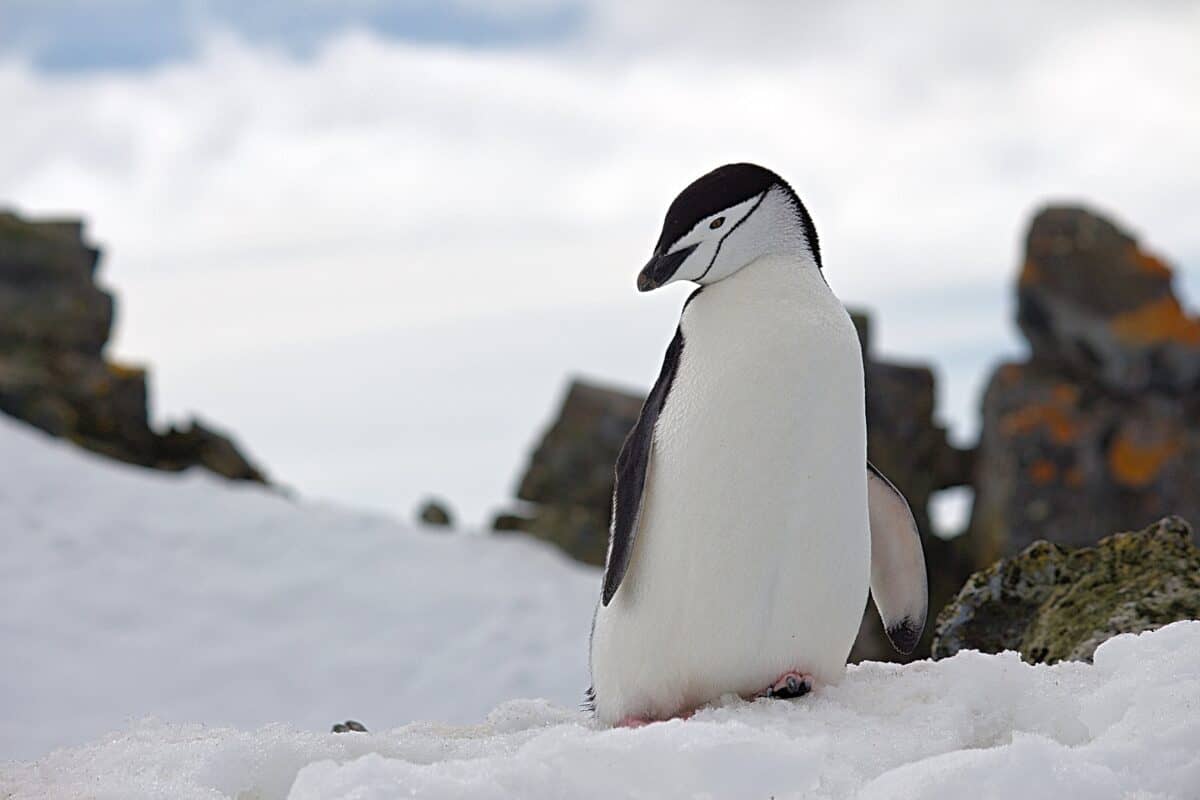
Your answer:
0;416;600;762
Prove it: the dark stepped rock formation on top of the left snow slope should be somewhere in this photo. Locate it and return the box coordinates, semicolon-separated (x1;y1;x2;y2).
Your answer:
0;212;265;482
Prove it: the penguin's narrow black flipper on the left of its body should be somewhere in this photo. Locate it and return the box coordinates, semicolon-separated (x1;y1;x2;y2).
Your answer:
601;329;683;606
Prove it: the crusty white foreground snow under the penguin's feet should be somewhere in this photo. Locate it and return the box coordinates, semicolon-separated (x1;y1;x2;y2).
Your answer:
0;621;1200;800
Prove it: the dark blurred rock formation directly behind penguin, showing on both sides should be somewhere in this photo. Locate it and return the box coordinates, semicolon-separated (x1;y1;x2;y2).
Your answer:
494;314;971;660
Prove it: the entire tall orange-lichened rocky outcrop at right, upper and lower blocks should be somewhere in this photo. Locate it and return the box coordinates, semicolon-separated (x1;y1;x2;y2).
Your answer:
971;207;1200;566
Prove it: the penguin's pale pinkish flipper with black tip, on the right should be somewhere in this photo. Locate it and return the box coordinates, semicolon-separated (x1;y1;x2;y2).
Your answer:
866;462;929;655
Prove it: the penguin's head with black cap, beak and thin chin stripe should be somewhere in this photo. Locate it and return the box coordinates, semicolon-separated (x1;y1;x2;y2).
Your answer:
637;164;821;291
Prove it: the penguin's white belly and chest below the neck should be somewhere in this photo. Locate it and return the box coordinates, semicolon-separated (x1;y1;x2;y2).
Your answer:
592;256;870;723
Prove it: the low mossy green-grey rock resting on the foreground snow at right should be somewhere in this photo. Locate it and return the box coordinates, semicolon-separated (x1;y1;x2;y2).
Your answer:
932;517;1200;663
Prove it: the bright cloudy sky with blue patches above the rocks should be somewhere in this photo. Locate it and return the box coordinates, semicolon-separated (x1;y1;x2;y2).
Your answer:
0;0;1200;532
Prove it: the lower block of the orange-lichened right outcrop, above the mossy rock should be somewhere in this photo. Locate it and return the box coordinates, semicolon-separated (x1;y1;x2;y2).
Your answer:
972;363;1200;566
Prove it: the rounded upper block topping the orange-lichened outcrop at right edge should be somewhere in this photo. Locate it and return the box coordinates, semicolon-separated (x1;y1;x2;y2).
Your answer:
1018;207;1200;395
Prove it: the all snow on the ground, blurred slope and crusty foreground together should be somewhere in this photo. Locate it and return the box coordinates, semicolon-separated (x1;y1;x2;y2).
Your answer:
0;412;1200;800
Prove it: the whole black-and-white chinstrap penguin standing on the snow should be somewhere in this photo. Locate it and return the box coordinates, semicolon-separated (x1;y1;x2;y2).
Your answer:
588;163;928;726
